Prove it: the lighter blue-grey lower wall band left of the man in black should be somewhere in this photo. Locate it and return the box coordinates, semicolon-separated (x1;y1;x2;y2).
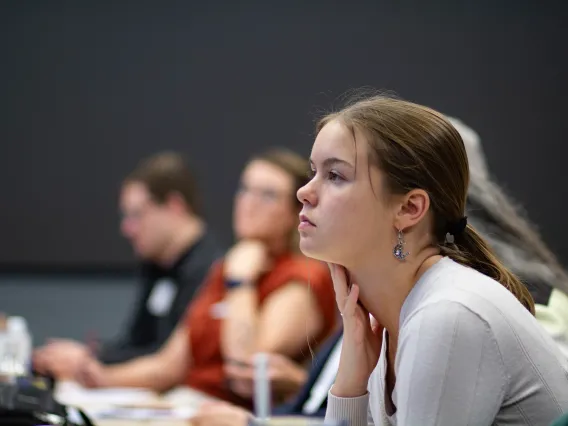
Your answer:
0;275;136;346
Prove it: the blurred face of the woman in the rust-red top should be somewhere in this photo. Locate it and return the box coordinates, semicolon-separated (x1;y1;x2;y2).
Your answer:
233;160;298;242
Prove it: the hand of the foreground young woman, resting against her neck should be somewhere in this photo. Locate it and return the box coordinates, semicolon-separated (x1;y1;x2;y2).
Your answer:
328;263;383;398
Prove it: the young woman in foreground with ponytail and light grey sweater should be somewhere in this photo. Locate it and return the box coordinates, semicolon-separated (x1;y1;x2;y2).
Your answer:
298;96;568;426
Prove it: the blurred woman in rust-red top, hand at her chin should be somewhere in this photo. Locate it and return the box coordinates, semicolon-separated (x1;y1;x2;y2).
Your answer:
71;150;337;407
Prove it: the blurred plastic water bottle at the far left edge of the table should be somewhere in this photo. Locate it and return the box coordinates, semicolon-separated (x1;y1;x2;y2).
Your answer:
6;316;32;377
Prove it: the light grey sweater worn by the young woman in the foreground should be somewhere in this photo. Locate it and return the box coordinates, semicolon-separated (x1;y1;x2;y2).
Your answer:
326;258;568;426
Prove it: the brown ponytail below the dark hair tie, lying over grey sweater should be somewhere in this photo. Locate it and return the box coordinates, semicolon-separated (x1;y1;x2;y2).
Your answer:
440;225;535;315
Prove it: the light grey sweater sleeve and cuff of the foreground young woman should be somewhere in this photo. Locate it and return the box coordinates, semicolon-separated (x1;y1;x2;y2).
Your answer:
326;301;507;426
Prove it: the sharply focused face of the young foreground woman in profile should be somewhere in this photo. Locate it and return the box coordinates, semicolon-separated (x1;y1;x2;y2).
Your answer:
297;121;396;266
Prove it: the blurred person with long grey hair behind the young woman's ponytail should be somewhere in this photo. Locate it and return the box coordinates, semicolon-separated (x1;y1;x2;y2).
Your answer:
448;117;568;357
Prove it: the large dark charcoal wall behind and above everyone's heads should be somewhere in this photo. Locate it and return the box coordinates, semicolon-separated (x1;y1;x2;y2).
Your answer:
0;0;568;268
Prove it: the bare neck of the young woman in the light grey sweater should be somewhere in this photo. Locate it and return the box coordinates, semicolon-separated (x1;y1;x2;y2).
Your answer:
349;248;442;340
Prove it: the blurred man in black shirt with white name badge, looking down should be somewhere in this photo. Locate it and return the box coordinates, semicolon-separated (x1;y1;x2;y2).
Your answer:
34;152;222;378
